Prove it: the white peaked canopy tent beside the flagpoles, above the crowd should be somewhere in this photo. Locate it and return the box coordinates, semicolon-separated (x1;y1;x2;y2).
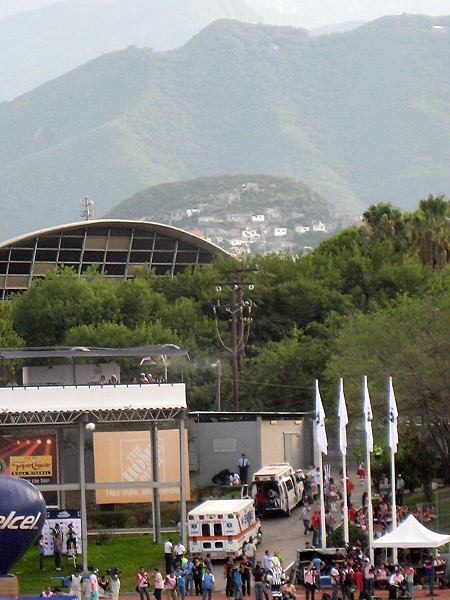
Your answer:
372;515;450;548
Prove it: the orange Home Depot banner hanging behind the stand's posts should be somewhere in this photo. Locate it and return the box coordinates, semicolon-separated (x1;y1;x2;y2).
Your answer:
94;429;190;504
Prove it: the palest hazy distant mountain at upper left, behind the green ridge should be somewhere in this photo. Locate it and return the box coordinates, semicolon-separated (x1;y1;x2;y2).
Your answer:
0;0;256;101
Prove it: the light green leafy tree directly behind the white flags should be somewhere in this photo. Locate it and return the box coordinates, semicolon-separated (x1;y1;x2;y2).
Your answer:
326;288;450;481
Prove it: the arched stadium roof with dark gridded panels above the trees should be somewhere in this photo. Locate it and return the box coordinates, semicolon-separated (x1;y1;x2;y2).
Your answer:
0;219;228;300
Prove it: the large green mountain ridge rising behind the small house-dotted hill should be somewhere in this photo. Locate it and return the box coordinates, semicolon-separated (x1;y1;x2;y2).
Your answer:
0;15;450;239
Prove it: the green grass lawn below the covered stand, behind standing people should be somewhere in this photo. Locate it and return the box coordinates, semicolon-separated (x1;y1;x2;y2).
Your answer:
12;535;164;596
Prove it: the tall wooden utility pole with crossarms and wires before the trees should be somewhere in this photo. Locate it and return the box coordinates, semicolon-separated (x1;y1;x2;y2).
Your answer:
213;269;255;412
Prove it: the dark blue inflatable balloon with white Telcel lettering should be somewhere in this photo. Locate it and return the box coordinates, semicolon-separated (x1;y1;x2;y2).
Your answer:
0;475;46;577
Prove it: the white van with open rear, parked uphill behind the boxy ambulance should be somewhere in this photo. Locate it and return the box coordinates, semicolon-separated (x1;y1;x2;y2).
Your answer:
250;463;303;516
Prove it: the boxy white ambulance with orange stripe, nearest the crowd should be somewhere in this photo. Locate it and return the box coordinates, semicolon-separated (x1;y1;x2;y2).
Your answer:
188;499;262;559
